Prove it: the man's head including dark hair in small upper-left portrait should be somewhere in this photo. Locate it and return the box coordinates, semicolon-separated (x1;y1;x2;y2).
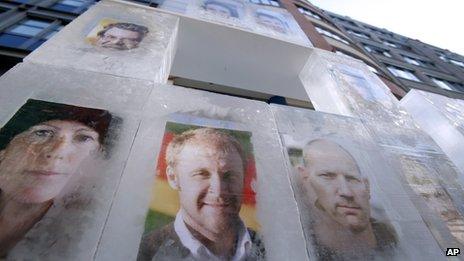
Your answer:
95;23;148;50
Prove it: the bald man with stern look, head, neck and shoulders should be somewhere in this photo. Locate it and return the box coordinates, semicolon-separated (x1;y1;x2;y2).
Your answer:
298;139;397;260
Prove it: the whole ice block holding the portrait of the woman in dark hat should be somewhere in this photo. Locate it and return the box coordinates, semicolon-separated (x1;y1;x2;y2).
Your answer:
0;63;153;260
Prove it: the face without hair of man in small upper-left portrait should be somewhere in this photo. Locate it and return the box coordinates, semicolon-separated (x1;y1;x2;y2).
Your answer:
97;27;141;50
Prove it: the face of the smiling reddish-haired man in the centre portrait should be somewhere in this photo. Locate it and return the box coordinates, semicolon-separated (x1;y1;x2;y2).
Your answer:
170;137;244;234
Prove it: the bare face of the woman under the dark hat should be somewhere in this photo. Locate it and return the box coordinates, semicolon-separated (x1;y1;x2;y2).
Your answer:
0;120;100;203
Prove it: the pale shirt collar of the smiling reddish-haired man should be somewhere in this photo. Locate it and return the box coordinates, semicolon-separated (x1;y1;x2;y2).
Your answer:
174;209;252;260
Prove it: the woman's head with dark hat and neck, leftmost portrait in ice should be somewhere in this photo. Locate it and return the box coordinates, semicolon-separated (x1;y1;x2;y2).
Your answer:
0;100;112;258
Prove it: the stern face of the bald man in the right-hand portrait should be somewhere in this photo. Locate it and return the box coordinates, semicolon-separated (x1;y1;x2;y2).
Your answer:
302;140;370;232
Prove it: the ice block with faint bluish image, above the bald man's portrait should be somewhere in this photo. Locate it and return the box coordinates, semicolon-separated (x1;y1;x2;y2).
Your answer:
300;50;404;122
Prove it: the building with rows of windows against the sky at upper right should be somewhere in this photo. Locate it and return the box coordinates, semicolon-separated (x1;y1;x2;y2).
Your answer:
282;1;464;98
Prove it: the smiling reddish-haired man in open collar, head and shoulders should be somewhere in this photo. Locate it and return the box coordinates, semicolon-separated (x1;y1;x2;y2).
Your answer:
138;128;264;261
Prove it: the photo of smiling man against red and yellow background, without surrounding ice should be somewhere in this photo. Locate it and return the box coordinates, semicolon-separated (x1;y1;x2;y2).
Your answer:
138;122;265;260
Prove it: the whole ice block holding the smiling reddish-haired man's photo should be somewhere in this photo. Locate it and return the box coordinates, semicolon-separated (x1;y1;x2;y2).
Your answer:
96;85;308;260
